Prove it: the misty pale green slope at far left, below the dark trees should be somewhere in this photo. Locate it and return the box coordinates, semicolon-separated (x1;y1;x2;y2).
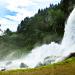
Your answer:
0;33;30;60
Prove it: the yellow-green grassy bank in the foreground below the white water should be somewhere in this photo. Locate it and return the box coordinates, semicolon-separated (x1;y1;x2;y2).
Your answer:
0;58;75;75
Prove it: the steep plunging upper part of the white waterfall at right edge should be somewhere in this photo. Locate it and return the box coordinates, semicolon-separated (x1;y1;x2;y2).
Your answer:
60;8;75;56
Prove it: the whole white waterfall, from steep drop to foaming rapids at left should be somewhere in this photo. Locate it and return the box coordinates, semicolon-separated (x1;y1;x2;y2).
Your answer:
0;8;75;69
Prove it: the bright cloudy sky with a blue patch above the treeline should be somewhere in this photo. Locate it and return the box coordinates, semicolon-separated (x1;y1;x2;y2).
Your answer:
0;0;60;31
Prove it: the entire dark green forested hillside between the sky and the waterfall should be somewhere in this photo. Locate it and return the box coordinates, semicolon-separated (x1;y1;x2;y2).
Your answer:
0;0;75;56
